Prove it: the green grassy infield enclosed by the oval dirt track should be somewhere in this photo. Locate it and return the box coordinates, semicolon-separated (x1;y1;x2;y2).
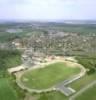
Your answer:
21;62;80;89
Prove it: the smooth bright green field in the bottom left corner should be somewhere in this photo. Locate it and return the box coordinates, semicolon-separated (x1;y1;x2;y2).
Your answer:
0;78;19;100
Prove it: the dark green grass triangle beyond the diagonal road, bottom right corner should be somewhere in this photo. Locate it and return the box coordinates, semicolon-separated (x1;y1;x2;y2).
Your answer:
75;85;96;100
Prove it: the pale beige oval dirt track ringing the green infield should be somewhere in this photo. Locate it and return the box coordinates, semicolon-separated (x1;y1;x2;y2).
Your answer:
16;59;86;96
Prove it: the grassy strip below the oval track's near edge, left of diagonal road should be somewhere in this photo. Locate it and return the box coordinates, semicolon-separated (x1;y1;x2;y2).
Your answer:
32;91;68;100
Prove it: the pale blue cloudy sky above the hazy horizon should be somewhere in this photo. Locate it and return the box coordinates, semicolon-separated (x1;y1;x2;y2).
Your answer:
0;0;96;21
